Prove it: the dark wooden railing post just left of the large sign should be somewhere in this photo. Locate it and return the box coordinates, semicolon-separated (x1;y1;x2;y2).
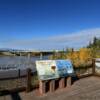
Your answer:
26;68;31;92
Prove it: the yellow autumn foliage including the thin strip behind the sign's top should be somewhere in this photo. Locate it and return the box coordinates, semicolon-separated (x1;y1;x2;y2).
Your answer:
50;48;96;67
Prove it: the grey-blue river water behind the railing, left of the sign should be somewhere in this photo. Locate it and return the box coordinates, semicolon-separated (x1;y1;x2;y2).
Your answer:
0;56;49;79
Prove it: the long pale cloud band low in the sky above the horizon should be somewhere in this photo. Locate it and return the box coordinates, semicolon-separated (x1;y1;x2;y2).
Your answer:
0;28;100;50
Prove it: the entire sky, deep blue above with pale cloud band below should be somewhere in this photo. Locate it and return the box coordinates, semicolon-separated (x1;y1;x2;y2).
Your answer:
0;0;100;50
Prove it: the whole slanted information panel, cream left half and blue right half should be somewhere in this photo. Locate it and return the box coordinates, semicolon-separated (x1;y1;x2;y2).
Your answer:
36;60;73;80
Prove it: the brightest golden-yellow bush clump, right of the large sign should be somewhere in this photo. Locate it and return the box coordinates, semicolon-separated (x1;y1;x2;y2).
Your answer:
67;48;92;67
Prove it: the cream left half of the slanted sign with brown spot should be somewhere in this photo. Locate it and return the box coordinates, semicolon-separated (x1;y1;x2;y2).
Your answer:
36;60;59;80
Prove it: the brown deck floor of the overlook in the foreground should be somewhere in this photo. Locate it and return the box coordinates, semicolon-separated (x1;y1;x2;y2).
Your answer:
0;76;100;100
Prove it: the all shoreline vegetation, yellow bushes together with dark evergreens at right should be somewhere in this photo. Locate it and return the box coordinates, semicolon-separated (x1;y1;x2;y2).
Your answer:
49;37;100;68
